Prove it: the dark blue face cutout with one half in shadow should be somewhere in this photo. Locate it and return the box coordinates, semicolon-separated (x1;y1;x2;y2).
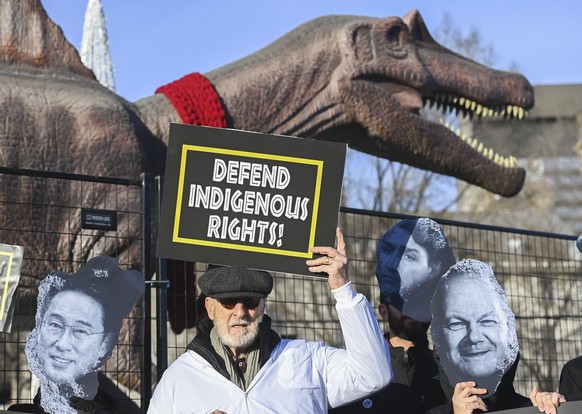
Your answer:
376;218;455;322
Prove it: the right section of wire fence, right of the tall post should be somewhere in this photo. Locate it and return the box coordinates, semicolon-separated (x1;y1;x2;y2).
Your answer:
162;208;582;402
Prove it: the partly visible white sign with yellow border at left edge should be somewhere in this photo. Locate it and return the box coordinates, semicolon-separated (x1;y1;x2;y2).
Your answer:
0;243;24;332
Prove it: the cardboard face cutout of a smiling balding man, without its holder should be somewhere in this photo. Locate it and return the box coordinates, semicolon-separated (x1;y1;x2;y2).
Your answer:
431;259;519;398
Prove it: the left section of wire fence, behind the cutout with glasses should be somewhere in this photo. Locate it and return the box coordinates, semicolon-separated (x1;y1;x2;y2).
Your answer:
0;168;151;413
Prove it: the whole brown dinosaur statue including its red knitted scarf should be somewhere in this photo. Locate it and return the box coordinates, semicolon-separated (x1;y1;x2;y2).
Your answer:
0;0;534;402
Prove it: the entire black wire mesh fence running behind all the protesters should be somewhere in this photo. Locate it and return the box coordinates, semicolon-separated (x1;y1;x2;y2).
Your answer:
0;169;582;413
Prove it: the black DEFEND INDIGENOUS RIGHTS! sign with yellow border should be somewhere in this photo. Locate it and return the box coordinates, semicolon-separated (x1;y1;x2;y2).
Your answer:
157;124;346;275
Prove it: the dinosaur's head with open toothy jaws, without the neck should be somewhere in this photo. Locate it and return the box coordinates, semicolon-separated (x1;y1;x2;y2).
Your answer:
338;10;534;196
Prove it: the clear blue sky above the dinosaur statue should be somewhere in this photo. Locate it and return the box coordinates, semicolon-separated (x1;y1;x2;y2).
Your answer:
41;0;582;101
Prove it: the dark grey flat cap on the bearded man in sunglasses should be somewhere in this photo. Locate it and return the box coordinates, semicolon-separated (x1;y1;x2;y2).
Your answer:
198;266;273;299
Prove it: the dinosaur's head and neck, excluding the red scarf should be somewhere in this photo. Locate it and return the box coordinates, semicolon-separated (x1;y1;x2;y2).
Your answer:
136;10;534;196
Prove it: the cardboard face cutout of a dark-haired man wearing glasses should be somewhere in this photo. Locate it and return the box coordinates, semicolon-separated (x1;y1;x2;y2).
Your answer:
25;256;145;413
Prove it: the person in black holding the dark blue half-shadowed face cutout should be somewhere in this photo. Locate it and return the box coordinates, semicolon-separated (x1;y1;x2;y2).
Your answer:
329;218;455;414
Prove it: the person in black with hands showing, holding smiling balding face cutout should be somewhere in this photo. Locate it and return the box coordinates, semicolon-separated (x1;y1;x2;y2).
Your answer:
429;259;565;414
